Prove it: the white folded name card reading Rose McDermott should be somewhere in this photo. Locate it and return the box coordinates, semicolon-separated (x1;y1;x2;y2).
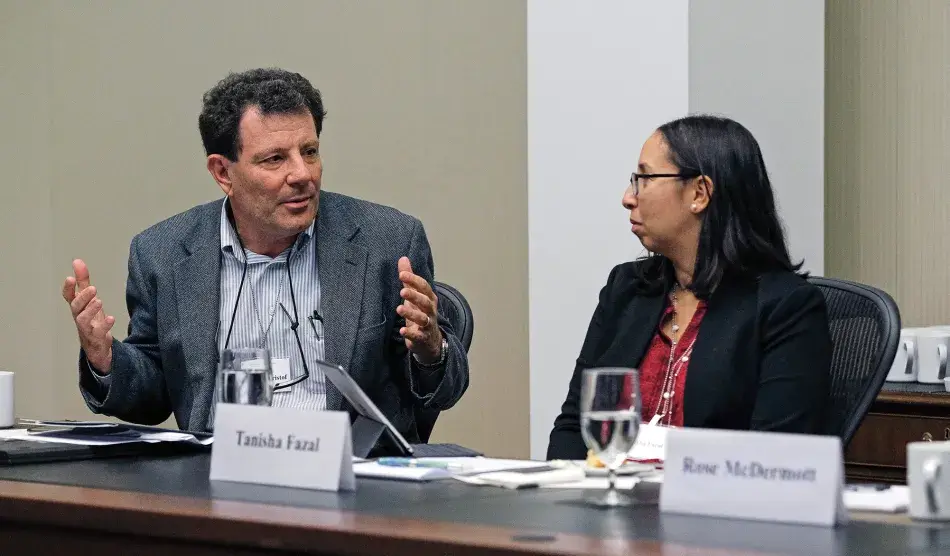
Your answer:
660;428;848;527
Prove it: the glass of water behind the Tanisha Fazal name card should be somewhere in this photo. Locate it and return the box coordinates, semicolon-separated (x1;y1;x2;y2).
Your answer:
217;348;274;405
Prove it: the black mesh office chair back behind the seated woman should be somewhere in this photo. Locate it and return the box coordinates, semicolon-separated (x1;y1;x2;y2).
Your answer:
808;276;901;446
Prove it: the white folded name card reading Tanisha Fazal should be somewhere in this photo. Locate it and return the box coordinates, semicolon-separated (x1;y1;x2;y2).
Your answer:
210;403;356;491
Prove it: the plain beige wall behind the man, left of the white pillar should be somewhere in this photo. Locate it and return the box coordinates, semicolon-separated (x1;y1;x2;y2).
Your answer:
0;0;528;456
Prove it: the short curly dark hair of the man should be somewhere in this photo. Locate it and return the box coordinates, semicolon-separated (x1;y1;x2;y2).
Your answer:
198;68;326;160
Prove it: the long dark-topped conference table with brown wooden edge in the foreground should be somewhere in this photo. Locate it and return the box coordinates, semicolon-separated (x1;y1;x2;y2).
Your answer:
0;453;950;556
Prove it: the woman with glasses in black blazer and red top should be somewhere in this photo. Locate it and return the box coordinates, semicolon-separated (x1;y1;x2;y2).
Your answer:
547;116;831;459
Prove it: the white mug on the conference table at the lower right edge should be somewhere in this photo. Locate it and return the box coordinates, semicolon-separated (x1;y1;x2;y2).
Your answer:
907;441;950;520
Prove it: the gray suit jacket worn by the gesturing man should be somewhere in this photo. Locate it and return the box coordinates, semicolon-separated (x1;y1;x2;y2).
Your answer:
79;192;468;442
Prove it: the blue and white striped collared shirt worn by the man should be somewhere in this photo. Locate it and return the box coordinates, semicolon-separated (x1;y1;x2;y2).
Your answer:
218;203;327;410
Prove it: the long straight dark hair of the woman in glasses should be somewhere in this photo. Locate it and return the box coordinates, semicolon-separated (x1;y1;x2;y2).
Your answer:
638;115;805;298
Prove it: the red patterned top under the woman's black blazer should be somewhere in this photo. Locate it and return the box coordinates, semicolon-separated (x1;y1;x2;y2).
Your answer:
639;301;706;427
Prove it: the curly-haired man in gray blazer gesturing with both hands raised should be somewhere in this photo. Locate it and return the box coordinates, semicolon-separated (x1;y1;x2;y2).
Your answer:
63;69;468;442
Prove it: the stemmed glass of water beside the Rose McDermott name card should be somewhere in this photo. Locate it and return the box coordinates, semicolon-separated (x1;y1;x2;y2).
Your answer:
580;368;640;507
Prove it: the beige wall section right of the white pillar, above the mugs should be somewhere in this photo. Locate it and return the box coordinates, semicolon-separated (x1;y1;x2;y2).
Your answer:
825;0;950;326
